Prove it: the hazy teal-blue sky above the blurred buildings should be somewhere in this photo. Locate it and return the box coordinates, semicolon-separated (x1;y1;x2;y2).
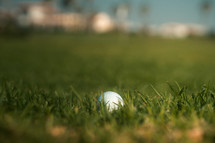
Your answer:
1;0;215;29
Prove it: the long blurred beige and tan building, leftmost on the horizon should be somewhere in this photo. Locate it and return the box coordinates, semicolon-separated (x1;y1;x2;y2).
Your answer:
17;2;86;31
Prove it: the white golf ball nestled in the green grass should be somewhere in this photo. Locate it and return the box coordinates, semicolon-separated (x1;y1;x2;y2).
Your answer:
98;91;124;112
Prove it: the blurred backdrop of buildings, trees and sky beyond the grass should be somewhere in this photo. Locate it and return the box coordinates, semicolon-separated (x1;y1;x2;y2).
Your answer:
0;0;215;38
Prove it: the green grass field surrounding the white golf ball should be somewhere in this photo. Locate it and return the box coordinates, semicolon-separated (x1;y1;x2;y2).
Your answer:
0;34;215;143
